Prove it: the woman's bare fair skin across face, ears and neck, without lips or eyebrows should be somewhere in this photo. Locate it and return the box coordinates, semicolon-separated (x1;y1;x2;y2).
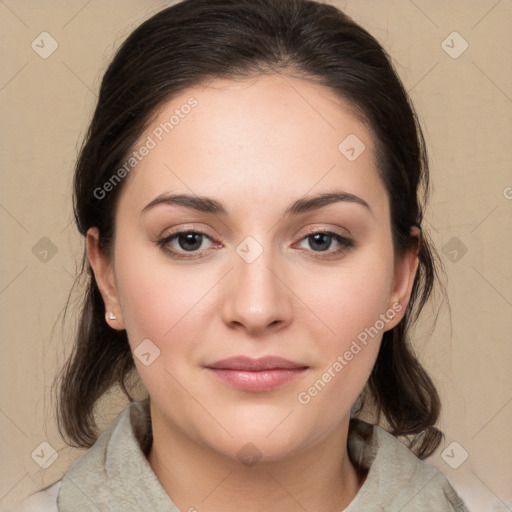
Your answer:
87;75;417;512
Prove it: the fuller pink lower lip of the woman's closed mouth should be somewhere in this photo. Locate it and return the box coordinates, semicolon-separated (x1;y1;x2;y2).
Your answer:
208;368;307;392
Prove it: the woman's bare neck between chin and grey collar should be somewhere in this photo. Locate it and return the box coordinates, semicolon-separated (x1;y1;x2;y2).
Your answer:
148;411;365;512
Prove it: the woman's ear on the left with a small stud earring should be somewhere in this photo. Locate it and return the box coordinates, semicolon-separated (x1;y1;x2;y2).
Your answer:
85;228;124;330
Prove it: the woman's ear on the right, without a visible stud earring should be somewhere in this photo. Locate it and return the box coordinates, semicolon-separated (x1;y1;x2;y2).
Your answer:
385;226;421;331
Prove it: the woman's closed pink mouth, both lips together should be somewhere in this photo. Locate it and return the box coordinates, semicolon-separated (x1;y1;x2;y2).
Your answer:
205;356;309;392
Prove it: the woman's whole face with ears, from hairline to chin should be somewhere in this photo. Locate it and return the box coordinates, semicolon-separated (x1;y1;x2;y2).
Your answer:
88;76;416;460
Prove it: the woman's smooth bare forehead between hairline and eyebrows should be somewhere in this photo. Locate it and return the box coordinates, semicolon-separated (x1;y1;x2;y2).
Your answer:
117;75;386;216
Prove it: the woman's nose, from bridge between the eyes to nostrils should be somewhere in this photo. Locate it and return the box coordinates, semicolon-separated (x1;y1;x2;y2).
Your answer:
222;245;293;335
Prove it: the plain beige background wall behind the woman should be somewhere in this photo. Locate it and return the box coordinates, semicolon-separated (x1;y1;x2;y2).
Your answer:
0;0;512;512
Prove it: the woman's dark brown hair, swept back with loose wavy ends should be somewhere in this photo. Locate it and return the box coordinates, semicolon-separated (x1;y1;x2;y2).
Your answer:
57;0;442;458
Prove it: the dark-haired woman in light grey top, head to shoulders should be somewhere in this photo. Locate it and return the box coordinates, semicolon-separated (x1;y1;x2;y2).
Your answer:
19;0;467;512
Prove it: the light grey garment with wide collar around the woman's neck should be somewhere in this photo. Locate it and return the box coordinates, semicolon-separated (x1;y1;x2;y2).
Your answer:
17;402;468;512
